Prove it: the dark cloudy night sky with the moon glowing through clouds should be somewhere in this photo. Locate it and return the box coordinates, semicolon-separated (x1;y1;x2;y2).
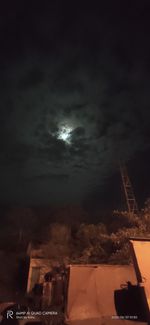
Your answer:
0;0;150;209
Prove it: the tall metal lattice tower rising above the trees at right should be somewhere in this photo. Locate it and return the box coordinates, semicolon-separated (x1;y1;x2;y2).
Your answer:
120;165;138;217
